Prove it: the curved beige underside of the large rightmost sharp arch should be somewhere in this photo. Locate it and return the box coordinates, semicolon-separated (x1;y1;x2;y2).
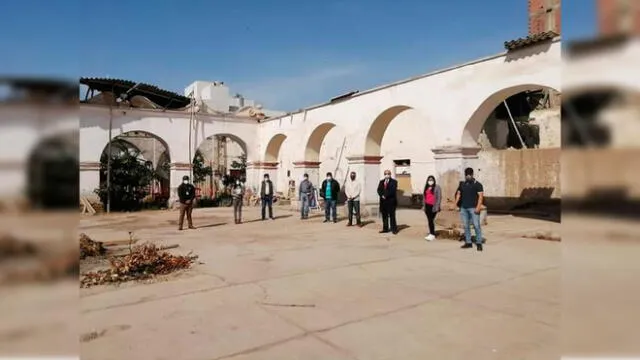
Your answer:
460;84;559;147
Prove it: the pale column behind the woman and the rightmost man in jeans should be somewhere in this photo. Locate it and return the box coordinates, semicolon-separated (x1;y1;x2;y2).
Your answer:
431;146;480;204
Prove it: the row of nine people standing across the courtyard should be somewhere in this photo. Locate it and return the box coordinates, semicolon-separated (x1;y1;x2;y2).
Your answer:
178;168;484;251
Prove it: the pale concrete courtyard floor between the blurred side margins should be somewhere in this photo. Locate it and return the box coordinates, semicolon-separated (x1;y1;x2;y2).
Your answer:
75;208;561;360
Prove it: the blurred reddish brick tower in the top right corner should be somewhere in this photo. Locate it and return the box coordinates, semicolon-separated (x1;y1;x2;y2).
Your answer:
597;0;640;36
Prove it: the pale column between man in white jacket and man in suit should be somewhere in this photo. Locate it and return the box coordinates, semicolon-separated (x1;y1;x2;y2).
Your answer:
347;155;382;216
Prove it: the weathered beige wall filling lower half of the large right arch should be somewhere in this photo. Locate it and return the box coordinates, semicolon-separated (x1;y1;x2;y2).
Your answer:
476;148;561;207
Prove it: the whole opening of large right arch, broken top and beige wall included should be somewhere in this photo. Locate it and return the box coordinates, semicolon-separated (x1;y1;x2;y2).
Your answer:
477;88;561;221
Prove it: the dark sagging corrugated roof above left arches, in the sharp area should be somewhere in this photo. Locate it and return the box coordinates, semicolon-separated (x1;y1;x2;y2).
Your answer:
80;77;191;109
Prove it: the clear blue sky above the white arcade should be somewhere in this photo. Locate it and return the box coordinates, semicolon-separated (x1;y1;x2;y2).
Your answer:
0;0;595;110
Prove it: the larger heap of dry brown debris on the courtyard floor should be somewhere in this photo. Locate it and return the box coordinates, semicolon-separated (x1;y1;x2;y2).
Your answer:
80;243;198;287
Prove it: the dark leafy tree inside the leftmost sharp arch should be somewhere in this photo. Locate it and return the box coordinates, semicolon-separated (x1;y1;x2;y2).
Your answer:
94;149;165;211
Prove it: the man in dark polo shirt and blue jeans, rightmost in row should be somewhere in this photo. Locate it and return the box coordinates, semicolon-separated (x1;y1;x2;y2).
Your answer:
456;168;484;251
